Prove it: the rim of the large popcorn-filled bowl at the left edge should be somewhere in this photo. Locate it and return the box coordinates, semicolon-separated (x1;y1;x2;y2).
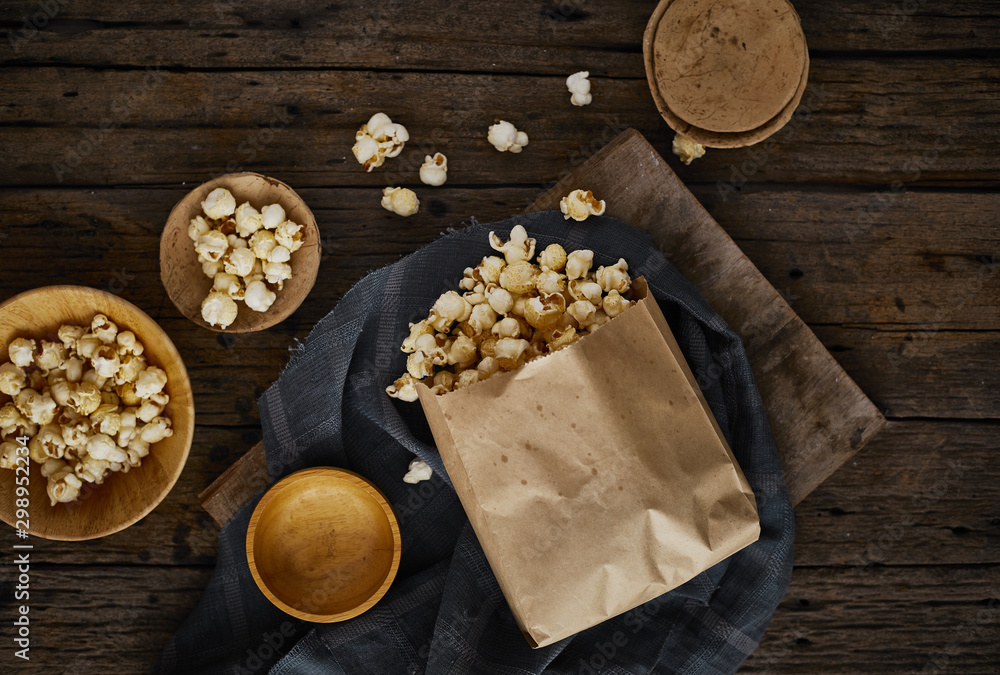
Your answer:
0;284;195;541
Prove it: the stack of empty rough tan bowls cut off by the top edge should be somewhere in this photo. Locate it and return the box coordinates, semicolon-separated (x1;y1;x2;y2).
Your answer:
643;0;809;148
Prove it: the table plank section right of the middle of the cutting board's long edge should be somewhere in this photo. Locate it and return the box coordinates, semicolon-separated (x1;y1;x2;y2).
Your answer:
695;188;1000;330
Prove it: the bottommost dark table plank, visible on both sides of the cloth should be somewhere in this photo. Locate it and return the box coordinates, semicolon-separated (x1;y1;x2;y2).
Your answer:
0;565;1000;675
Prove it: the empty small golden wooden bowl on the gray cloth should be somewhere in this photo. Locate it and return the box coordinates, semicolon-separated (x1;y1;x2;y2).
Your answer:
247;467;400;623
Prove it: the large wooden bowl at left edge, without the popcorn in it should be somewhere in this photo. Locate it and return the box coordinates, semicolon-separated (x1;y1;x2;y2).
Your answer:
0;286;194;541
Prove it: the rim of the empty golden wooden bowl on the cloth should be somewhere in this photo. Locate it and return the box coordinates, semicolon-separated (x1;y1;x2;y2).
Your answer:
246;466;402;623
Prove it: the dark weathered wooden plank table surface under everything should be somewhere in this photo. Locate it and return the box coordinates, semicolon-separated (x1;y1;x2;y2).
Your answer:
0;0;1000;674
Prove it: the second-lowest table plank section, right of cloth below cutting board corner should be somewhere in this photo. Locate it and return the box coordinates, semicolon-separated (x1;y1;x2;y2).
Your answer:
795;421;1000;567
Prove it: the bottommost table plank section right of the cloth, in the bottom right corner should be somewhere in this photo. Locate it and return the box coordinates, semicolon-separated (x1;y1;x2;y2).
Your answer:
740;566;1000;675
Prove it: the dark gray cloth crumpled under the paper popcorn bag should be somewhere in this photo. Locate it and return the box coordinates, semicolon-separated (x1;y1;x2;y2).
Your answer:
157;212;794;675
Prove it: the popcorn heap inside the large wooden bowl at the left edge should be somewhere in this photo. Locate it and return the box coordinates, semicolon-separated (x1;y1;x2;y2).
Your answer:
0;320;174;506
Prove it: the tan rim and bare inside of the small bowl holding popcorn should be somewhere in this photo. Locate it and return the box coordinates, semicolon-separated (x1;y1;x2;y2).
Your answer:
160;171;319;333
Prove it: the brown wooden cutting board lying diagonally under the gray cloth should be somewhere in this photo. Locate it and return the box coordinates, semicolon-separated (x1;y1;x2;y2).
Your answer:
199;129;885;525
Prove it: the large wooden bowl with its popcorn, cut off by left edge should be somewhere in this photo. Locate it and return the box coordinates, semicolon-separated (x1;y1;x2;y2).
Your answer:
0;286;194;541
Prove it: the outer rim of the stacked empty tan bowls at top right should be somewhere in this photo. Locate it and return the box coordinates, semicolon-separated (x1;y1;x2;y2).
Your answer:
642;0;809;148
